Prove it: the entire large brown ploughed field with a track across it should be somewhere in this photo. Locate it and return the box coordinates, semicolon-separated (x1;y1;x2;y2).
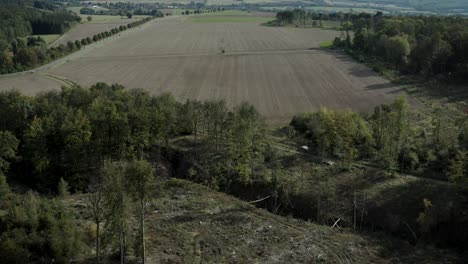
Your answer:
0;14;422;122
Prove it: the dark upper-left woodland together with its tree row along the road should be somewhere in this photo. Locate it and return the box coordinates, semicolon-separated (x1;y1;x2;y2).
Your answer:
0;2;151;74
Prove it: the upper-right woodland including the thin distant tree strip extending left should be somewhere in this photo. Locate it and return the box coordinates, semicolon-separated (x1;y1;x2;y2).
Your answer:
277;10;468;82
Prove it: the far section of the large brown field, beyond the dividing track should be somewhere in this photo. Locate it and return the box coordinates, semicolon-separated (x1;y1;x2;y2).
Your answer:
80;17;339;59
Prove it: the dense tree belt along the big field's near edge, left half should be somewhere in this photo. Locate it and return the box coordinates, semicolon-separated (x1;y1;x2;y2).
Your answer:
0;83;265;193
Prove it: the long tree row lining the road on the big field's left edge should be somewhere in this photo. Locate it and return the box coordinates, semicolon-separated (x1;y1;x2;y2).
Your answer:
0;17;152;74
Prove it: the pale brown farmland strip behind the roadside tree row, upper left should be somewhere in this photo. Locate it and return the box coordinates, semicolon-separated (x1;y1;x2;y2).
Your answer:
50;16;142;47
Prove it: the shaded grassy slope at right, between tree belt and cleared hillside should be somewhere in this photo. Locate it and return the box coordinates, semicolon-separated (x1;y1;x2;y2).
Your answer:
173;127;468;252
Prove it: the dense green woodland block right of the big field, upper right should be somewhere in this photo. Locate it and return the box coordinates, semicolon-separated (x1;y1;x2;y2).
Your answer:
350;13;468;82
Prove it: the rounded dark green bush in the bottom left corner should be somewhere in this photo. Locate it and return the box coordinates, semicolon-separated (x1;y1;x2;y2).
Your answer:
0;192;83;263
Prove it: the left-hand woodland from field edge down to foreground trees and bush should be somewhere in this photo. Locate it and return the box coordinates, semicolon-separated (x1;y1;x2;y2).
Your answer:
0;83;264;263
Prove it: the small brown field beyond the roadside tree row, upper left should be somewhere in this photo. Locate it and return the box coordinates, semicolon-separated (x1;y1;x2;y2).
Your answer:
50;16;139;47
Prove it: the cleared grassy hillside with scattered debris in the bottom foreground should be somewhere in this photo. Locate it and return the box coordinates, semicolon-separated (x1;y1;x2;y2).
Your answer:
67;179;453;264
